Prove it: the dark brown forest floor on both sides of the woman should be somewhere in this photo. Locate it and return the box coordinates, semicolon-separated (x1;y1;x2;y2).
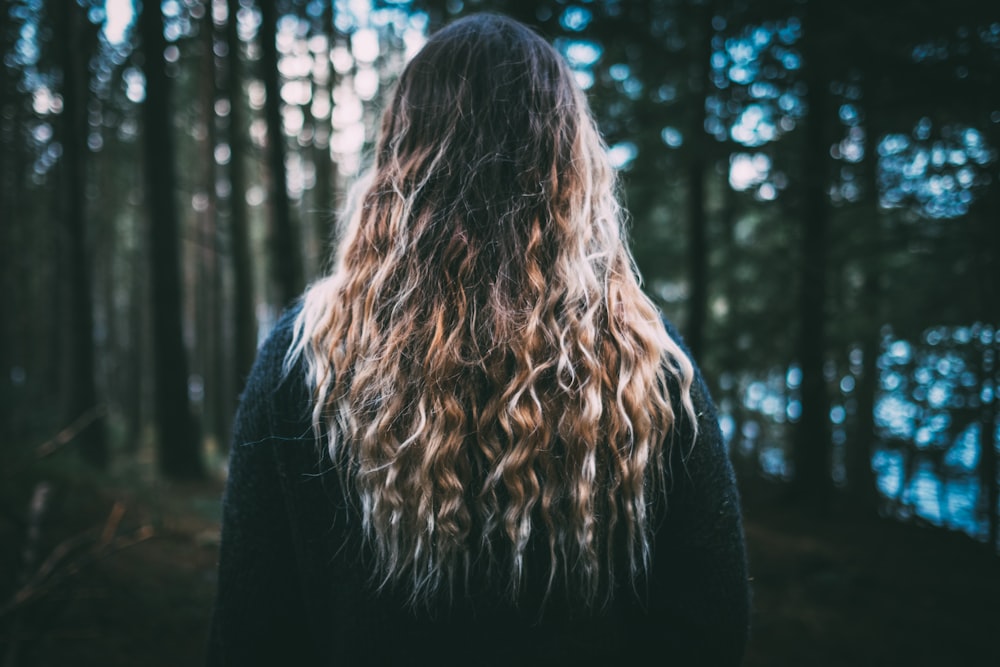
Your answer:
0;460;1000;667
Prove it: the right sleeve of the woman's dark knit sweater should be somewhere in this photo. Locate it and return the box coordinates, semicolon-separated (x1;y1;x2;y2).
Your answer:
636;325;750;666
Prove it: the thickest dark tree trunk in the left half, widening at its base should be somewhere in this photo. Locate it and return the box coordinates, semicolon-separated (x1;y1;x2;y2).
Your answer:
139;3;204;479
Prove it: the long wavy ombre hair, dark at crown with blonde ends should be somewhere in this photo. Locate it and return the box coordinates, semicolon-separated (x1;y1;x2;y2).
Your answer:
288;15;695;604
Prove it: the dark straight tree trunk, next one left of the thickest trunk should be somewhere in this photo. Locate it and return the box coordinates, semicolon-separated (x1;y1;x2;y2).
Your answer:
54;3;108;468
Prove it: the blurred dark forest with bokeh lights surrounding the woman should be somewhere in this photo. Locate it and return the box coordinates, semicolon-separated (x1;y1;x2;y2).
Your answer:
0;0;1000;667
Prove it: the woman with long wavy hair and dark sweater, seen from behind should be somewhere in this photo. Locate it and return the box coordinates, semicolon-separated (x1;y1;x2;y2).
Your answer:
210;15;748;665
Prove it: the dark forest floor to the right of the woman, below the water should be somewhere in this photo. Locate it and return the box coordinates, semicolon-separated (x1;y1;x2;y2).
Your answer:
744;486;1000;667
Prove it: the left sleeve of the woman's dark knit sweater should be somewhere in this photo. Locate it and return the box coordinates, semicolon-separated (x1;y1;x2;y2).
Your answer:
207;316;320;666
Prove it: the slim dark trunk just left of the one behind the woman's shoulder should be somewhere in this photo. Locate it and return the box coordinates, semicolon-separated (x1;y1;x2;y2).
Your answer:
225;0;257;400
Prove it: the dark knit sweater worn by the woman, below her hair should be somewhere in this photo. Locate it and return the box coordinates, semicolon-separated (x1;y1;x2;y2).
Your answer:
208;311;749;666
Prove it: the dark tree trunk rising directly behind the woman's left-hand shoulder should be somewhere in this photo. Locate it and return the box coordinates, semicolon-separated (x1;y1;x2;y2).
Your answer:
259;1;304;307
